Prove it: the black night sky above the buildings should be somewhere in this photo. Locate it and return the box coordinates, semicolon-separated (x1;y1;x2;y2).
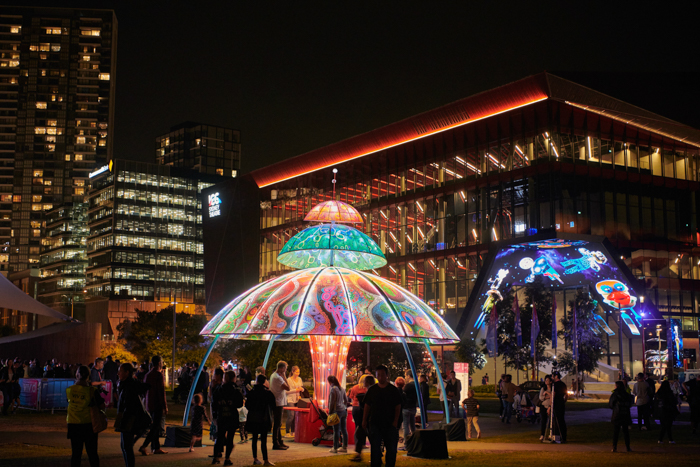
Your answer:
42;0;700;171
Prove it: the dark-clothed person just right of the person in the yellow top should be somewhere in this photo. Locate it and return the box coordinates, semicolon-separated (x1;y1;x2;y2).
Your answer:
114;363;150;467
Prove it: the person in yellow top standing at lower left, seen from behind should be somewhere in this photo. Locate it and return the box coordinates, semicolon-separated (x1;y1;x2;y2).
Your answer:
66;365;104;467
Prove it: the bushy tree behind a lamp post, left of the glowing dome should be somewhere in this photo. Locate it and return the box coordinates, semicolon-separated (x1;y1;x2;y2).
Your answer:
117;306;220;368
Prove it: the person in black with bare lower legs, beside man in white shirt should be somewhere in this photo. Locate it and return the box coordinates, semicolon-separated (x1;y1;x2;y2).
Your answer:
246;375;277;465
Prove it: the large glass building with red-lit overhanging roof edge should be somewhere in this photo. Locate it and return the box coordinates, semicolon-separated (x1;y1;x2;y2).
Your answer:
251;73;700;348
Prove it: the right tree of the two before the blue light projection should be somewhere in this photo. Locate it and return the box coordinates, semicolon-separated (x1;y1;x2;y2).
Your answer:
556;289;607;373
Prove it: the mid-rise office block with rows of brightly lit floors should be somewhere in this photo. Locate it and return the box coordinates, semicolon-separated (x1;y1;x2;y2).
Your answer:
85;160;224;334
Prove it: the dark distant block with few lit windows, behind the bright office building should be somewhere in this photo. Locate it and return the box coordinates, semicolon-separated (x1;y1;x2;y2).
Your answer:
156;122;241;177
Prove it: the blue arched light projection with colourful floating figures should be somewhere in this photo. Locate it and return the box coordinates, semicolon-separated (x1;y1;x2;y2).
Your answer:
474;238;641;335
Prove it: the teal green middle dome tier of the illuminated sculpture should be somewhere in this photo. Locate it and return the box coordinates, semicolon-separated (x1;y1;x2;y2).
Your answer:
277;224;386;271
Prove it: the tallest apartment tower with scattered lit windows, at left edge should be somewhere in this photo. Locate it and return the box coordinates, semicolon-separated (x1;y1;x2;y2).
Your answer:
0;7;117;278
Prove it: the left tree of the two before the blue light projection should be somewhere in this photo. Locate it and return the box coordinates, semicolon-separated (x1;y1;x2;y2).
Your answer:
495;276;552;376
